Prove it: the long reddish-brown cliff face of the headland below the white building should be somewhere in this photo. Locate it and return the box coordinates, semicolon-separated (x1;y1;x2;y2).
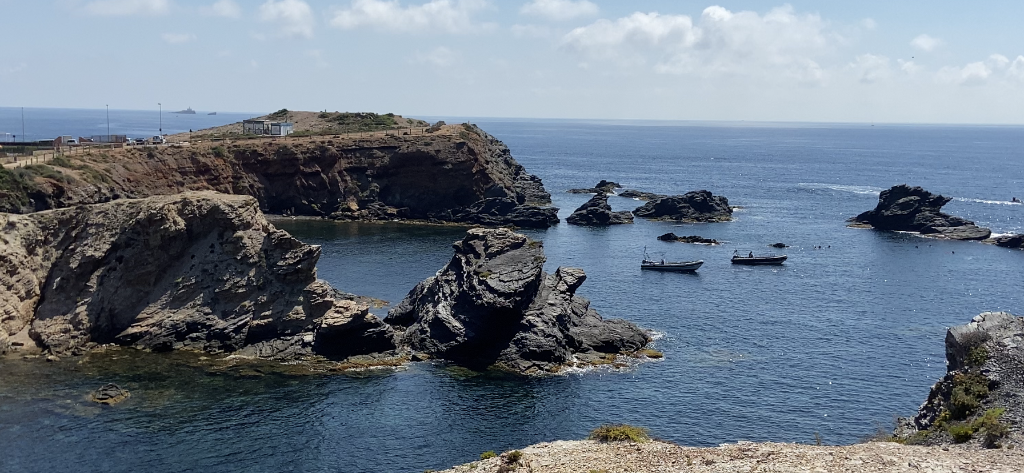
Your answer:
0;125;558;227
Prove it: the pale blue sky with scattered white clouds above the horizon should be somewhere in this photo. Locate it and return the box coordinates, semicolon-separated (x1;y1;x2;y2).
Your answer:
0;0;1024;124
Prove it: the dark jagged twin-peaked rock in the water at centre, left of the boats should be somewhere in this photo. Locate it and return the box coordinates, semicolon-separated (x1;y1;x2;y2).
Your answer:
385;228;650;373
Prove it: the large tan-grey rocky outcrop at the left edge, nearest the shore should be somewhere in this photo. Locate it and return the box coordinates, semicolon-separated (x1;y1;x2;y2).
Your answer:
0;192;395;359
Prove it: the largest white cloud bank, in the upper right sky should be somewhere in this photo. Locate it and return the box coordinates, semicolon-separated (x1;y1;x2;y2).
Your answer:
563;6;837;83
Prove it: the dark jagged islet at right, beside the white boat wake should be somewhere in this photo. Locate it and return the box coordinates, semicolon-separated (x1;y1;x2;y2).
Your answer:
850;184;992;240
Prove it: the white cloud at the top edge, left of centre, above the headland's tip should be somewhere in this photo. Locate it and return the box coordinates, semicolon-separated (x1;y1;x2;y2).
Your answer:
331;0;492;33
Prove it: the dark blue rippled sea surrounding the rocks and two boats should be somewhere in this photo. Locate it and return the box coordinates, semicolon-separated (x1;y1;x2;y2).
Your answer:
0;109;1024;473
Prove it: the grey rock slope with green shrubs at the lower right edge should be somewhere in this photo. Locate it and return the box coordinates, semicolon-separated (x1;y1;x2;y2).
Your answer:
894;312;1024;447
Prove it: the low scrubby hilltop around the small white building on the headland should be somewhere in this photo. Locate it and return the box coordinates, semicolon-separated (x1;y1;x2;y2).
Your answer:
167;109;430;142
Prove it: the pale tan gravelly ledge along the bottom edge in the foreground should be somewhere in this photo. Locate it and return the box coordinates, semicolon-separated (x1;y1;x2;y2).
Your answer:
442;440;1024;473
